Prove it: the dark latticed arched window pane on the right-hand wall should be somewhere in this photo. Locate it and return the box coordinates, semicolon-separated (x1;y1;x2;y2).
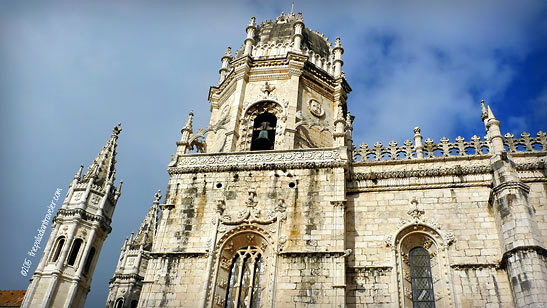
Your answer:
409;247;435;308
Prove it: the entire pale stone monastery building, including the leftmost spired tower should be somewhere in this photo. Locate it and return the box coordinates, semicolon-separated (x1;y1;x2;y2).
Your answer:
23;13;547;308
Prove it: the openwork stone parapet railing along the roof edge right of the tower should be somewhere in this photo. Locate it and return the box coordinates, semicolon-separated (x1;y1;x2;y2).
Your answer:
353;128;547;161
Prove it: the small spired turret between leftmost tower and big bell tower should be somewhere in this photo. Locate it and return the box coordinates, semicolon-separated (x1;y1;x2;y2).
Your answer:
106;190;161;308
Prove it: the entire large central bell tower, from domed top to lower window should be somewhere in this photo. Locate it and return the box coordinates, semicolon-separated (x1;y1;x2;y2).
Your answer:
135;13;353;307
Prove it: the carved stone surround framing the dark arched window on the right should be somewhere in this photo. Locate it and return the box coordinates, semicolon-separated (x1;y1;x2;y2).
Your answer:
386;199;455;308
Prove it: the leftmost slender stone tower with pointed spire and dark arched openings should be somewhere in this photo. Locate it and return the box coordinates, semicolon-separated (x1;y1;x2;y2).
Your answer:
22;124;122;308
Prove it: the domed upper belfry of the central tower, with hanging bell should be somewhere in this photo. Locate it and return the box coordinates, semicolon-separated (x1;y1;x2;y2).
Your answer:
192;13;352;153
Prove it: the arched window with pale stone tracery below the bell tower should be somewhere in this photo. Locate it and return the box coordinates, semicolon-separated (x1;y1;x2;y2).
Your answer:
224;246;264;308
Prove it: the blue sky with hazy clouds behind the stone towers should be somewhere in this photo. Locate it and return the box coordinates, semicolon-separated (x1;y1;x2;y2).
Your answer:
0;0;547;307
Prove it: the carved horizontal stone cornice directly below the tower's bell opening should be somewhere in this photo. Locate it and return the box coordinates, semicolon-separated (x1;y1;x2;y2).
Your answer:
167;147;349;175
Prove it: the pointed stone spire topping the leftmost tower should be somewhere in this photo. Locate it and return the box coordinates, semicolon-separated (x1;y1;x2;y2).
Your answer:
83;123;122;188
